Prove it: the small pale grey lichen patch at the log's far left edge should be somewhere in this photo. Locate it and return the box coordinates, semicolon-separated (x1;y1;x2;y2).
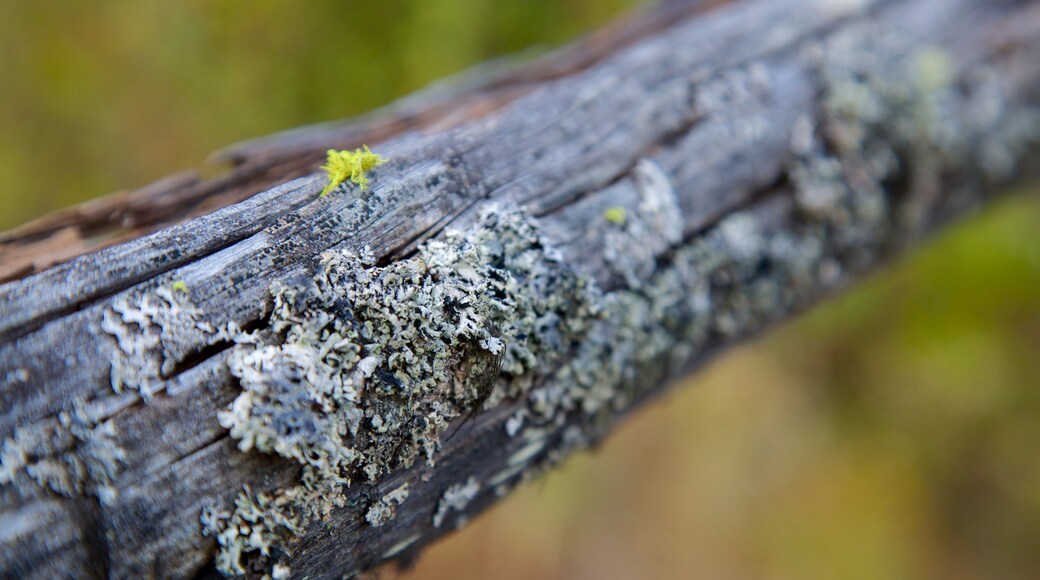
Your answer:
0;399;126;504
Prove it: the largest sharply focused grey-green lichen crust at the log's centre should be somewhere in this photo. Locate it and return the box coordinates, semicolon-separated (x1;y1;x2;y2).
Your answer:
204;210;598;573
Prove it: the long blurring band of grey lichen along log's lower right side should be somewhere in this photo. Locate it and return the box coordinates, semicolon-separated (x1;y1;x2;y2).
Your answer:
489;27;1037;494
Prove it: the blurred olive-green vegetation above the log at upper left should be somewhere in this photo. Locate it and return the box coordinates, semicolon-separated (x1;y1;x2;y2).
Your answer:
0;0;639;230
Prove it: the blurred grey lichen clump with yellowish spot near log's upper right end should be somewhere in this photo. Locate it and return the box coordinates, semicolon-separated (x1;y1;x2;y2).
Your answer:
791;26;1040;245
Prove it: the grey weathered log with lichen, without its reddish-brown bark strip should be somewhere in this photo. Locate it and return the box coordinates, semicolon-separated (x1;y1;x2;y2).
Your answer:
0;0;1040;576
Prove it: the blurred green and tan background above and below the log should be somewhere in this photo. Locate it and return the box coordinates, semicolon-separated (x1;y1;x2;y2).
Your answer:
0;0;1040;579
